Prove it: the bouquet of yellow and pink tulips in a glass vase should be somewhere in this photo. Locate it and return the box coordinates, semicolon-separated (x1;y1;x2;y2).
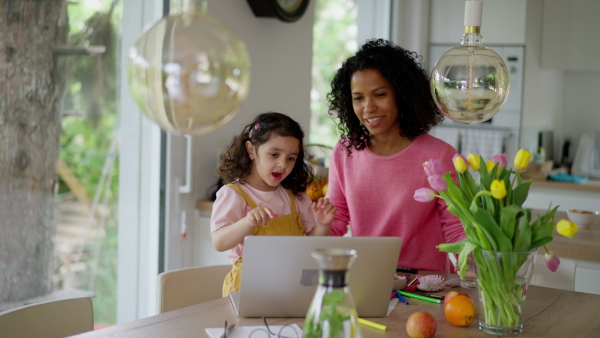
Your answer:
414;149;578;327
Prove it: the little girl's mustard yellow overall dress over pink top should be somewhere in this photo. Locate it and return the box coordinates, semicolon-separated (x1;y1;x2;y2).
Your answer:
223;184;306;297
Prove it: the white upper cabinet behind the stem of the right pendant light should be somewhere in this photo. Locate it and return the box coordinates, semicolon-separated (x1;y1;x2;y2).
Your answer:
429;0;527;45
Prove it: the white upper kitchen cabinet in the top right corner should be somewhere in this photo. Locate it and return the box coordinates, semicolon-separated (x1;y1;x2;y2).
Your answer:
541;0;600;72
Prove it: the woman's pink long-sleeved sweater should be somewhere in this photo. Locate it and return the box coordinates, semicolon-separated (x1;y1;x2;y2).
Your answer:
327;134;466;272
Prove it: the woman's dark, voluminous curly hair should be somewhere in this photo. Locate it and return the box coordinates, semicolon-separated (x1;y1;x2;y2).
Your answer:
327;39;444;155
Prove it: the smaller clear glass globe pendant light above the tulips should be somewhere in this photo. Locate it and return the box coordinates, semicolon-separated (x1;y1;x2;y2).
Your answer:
430;0;509;124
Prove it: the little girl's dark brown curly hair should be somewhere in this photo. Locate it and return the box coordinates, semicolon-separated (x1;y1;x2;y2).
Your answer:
217;112;314;195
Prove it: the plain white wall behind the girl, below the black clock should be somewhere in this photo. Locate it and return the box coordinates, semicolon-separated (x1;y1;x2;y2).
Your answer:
193;0;315;199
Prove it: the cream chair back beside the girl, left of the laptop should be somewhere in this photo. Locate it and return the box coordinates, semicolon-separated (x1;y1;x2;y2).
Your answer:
157;265;231;313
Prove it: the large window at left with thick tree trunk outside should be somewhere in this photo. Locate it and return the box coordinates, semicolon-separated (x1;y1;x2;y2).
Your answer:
0;0;122;325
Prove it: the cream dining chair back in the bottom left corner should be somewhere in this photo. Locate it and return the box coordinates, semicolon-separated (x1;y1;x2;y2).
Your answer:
0;297;94;338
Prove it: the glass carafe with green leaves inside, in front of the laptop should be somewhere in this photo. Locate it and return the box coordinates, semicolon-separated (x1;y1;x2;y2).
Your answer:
303;249;361;338
